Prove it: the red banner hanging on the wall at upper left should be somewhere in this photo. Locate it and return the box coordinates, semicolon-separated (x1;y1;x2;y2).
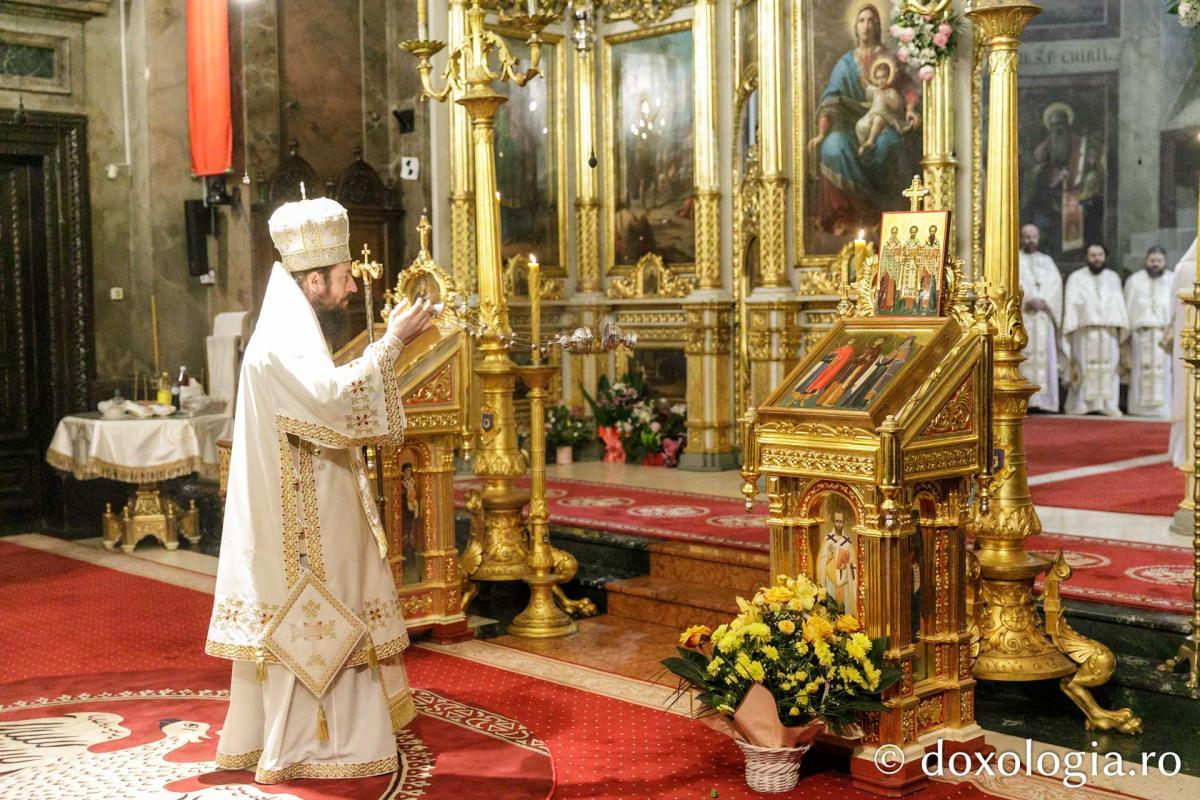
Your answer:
187;0;233;175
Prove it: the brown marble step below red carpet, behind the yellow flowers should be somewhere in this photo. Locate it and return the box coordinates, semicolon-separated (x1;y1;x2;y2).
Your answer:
605;576;739;631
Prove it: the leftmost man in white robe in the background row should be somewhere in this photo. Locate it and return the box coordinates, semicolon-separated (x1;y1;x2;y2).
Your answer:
1020;225;1062;414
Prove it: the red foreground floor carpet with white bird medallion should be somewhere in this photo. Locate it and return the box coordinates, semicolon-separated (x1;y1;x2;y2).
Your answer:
0;545;1012;800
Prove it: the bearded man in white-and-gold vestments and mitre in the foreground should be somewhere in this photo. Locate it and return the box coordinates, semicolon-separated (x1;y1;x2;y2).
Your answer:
205;199;430;783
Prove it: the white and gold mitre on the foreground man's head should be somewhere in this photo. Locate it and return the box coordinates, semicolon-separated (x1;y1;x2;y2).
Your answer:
266;192;350;272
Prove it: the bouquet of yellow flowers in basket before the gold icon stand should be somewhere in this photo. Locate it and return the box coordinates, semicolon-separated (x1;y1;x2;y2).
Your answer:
661;576;900;747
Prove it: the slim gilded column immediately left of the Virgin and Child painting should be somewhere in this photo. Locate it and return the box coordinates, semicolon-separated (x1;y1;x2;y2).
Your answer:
758;0;788;288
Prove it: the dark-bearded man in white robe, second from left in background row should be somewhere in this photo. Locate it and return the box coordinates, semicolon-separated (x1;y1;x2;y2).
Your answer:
1062;245;1129;416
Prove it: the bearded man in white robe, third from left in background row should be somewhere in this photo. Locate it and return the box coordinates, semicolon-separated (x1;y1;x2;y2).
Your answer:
1124;246;1175;417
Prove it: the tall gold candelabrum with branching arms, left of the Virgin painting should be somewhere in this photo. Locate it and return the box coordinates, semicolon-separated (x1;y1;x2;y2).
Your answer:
401;0;552;581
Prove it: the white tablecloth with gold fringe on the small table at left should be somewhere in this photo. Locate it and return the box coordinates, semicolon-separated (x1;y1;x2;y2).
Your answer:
46;411;233;483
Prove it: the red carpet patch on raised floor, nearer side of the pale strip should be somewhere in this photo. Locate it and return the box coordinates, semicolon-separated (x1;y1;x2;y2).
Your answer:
1030;463;1184;517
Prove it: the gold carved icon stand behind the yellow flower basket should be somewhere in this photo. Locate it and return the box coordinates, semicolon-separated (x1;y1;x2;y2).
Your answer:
742;258;991;796
